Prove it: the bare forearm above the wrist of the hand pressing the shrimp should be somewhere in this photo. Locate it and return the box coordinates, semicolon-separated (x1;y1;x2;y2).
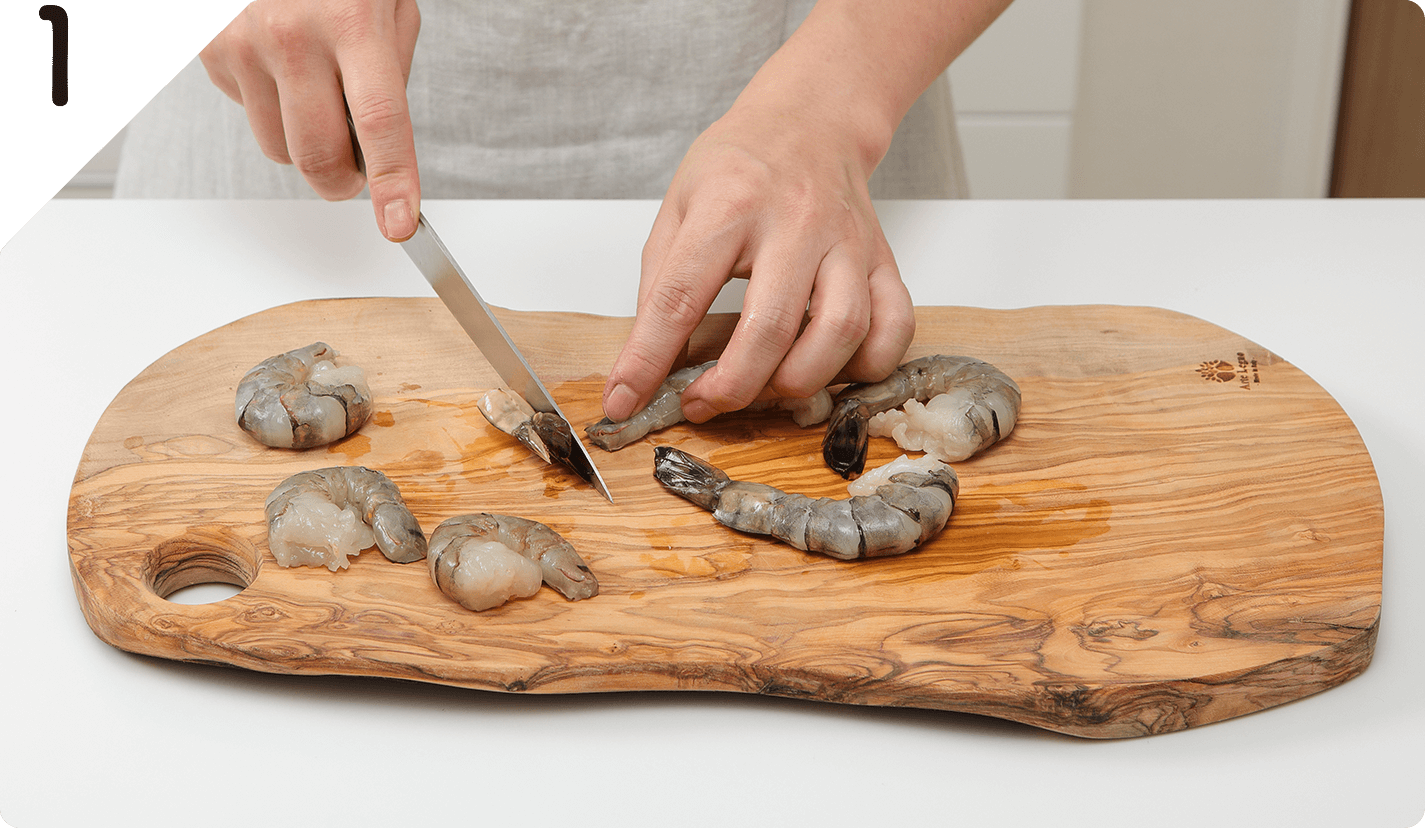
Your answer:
738;0;1010;175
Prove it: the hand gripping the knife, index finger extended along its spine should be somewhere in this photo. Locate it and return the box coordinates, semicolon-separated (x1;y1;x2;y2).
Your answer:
200;0;420;241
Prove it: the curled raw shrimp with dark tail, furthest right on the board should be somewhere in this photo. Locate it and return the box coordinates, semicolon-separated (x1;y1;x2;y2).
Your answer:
821;353;1020;477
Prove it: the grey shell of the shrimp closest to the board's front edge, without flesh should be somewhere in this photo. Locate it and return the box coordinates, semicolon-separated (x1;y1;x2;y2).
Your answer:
426;512;599;611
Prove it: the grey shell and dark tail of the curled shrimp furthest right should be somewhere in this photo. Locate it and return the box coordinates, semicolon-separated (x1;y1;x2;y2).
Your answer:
821;353;1020;479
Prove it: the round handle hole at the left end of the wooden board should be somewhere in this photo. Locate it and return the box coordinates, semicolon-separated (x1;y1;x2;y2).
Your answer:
144;526;259;604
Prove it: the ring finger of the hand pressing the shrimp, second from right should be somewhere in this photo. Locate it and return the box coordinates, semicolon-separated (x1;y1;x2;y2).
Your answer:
768;245;872;398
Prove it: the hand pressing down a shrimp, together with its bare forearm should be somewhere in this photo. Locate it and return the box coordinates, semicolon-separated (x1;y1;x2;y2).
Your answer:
604;0;1009;423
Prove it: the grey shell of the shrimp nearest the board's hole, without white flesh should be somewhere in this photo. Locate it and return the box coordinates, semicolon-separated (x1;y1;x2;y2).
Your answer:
264;466;426;563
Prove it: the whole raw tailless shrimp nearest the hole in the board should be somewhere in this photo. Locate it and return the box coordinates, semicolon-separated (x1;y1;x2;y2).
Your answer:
265;466;426;571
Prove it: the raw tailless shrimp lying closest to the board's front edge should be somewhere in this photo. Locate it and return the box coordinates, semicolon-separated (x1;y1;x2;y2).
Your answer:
426;513;599;611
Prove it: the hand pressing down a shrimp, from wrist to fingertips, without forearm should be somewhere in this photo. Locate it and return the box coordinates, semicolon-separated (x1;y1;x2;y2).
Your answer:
604;89;915;422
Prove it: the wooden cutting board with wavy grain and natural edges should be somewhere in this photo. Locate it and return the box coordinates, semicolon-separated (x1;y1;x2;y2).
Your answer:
68;299;1384;737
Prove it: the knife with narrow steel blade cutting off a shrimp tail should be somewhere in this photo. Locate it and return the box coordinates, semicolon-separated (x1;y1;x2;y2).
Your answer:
346;113;614;503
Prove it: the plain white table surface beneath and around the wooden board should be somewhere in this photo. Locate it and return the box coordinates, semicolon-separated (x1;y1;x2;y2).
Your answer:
0;201;1425;828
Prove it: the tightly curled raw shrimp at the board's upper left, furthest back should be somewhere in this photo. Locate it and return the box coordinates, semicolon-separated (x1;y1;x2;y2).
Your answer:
234;342;372;449
